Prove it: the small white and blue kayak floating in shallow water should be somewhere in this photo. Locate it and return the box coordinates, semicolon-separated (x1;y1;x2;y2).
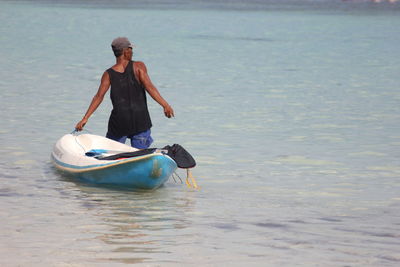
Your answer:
51;132;180;189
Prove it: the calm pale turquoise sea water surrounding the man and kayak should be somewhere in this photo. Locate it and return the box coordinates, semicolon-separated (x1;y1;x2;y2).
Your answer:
0;0;400;266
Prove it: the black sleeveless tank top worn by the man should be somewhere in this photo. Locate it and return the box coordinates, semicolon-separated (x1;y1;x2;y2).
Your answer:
107;61;152;137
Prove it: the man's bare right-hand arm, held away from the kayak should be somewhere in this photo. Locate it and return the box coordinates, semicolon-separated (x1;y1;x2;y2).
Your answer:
134;61;174;118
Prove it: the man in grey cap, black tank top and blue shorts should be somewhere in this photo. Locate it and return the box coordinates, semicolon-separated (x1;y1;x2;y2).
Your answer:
75;37;174;149
